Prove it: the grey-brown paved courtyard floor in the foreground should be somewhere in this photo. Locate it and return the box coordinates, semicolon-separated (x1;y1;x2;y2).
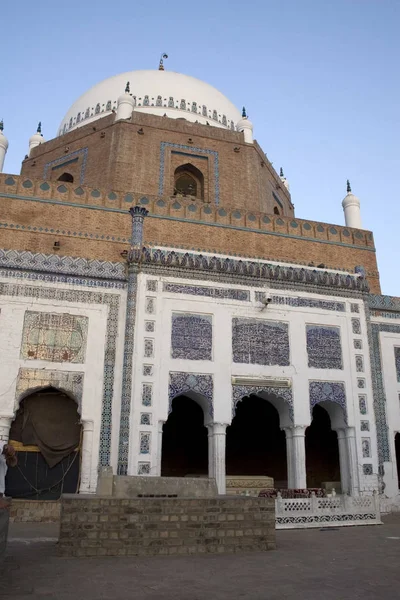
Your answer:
0;515;400;600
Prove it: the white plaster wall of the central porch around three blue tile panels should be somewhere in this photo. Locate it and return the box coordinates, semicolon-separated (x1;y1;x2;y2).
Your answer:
129;274;377;489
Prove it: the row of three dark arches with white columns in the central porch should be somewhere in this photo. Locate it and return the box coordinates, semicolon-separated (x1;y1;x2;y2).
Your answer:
161;395;358;493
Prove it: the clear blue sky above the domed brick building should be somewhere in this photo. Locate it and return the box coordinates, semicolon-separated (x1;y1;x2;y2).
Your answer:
0;0;400;296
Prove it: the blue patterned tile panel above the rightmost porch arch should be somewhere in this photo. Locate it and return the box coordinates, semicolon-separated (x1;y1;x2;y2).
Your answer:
306;325;343;369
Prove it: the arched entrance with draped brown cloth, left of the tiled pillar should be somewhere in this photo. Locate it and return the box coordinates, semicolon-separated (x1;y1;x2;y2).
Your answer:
6;387;81;500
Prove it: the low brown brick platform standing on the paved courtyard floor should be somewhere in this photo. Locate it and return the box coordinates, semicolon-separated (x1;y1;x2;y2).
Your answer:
58;494;275;557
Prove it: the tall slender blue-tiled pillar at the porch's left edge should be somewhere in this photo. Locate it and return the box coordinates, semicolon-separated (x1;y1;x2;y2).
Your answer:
117;206;148;475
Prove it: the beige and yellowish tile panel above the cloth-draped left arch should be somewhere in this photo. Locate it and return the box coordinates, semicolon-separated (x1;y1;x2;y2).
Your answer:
21;311;89;363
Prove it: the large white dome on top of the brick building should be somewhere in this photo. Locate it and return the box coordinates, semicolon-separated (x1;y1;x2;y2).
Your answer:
58;71;241;135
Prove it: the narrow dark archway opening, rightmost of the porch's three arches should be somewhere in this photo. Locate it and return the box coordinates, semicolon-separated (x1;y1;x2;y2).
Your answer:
305;404;341;491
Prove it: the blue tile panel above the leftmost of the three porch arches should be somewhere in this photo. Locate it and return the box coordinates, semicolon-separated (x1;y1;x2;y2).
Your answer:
171;313;212;360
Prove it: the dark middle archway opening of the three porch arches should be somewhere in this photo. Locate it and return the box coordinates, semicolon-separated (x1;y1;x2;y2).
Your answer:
226;395;287;488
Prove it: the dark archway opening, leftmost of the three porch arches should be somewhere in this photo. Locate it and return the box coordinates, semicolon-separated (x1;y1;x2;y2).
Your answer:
161;395;208;477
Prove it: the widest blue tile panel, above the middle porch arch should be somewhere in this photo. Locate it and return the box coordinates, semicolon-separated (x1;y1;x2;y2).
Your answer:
232;318;290;367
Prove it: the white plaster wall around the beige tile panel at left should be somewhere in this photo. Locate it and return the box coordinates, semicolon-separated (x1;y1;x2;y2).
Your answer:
0;279;121;491
